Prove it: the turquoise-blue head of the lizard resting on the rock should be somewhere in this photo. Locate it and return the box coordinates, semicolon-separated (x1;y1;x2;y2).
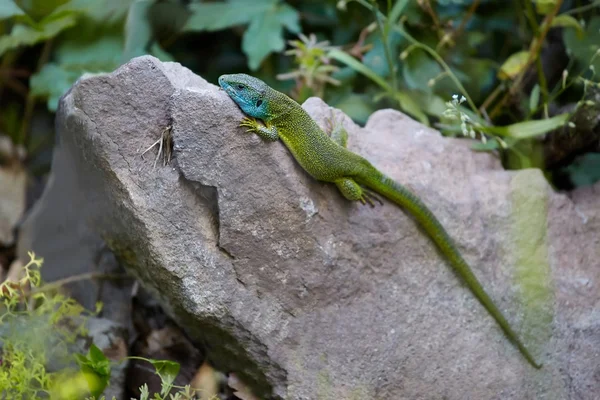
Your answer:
219;74;272;120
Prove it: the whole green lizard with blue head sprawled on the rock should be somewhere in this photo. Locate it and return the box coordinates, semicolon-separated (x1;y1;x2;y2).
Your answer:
219;74;541;368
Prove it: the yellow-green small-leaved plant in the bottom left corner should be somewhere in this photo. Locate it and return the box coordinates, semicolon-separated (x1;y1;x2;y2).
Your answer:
0;253;89;399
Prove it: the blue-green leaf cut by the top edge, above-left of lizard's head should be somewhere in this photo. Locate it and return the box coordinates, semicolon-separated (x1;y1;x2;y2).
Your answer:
183;0;279;31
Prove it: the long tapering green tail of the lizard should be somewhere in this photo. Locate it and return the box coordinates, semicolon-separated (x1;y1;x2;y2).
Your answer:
354;168;541;369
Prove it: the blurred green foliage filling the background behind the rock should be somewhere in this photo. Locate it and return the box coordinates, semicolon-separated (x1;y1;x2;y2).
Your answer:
0;0;600;187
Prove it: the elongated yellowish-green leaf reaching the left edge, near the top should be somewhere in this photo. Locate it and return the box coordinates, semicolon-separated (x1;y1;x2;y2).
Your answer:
0;12;76;56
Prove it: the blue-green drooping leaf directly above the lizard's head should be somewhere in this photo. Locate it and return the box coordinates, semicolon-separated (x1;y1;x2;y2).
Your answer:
242;4;300;70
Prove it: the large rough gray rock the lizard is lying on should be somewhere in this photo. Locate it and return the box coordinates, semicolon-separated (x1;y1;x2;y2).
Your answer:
23;57;600;399
